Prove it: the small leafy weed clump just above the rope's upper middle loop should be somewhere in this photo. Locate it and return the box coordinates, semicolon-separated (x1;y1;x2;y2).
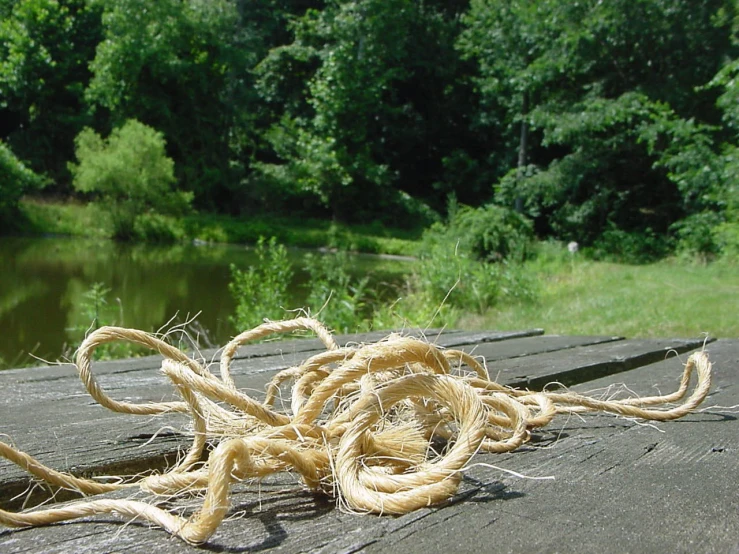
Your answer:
305;251;369;333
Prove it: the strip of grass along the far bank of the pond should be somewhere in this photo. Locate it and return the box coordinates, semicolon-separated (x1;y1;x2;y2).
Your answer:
15;198;422;256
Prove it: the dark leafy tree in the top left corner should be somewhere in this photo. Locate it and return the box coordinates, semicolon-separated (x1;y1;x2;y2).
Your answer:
0;0;100;187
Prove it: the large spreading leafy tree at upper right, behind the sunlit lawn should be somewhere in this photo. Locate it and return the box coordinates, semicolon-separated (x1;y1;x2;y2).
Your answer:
460;0;734;252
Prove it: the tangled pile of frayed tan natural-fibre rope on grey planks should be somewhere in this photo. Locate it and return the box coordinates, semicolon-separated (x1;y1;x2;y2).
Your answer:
0;318;711;544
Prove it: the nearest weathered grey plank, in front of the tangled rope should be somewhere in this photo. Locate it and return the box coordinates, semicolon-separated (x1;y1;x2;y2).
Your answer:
0;340;739;554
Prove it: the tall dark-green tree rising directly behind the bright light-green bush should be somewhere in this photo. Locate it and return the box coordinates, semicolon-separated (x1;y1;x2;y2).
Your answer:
86;0;256;209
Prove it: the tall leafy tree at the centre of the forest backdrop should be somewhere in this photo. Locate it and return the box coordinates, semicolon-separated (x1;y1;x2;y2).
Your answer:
257;0;489;221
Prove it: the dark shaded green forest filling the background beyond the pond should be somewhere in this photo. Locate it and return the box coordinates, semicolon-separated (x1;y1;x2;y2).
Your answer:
0;0;739;257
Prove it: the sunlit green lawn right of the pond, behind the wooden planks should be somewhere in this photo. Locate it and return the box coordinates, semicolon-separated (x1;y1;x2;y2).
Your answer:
459;245;739;338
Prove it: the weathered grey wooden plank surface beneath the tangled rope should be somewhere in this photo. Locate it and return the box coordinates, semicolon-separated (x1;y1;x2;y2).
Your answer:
0;330;739;554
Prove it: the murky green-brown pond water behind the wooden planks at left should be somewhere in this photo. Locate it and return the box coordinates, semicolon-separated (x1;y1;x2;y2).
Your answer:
0;237;411;369
